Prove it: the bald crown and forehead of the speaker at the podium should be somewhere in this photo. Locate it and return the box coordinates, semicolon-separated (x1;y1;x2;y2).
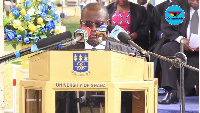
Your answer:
81;3;109;20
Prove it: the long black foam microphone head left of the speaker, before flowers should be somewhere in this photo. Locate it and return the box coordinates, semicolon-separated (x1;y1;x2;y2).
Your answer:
35;31;72;49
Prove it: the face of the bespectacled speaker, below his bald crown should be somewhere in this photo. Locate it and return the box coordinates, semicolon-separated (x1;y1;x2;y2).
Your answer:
80;10;108;47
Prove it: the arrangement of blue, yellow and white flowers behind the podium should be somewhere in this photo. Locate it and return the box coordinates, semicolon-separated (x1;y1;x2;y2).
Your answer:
4;0;63;48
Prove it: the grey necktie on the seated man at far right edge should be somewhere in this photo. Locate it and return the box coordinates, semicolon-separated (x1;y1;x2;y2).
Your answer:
190;10;199;36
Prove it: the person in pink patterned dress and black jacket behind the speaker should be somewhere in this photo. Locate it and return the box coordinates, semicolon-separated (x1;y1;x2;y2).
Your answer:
107;0;149;49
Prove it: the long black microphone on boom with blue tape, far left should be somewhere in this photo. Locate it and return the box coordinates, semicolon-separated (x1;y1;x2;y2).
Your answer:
0;31;72;63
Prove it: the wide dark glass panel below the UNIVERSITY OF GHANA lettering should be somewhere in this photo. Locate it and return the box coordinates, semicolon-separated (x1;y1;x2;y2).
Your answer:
55;91;105;113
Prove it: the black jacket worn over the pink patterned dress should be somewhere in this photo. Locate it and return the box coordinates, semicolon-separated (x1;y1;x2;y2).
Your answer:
107;2;149;49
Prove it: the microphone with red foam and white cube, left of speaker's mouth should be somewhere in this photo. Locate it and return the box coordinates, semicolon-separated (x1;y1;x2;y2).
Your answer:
74;27;91;42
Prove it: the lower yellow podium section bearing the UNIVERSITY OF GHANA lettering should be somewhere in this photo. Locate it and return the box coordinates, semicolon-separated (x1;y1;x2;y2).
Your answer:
20;79;158;113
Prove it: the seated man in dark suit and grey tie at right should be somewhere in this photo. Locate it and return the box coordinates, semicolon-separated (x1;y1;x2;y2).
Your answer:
158;0;199;104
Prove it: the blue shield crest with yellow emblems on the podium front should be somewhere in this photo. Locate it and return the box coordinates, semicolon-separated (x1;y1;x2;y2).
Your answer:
73;53;88;72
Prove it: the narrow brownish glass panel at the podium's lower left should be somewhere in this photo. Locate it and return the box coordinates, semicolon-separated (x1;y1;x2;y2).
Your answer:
25;89;42;113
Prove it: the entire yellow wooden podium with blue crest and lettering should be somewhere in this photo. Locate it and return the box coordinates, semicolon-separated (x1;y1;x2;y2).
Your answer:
20;51;158;113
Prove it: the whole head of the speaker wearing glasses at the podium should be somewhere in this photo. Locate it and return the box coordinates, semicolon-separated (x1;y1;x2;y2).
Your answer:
80;3;109;47
